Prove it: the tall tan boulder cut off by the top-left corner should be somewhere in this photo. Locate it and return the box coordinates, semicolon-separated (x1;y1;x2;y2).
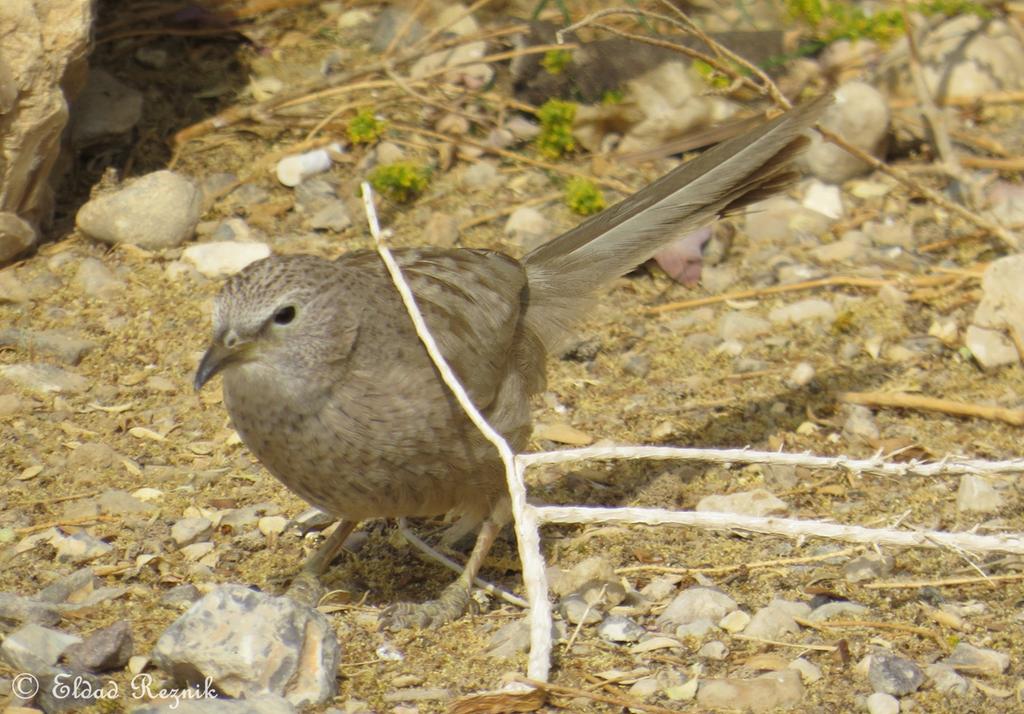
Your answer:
0;0;93;263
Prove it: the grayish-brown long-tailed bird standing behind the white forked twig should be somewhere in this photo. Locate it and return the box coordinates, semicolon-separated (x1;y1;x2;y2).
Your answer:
194;95;831;629
